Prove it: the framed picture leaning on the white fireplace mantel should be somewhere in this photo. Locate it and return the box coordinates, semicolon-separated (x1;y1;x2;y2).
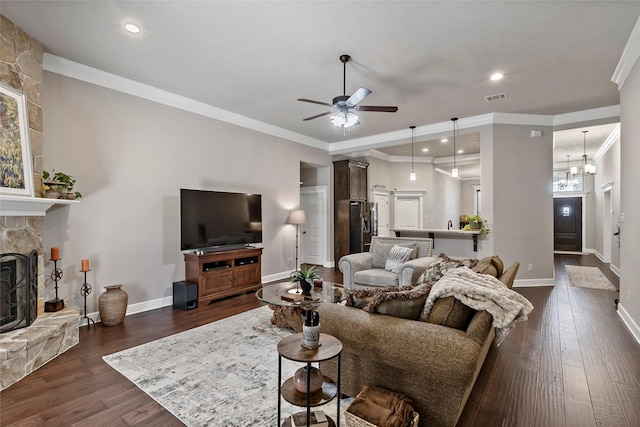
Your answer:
0;83;33;197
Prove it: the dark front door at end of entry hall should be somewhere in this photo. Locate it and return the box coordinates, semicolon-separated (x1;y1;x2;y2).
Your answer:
553;197;582;252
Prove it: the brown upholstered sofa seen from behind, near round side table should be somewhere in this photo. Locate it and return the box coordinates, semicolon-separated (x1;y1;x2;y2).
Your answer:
318;263;519;427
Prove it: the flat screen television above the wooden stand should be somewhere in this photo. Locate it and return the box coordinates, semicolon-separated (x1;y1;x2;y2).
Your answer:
180;188;262;251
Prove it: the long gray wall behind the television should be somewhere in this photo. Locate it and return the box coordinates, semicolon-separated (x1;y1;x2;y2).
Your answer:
44;73;331;312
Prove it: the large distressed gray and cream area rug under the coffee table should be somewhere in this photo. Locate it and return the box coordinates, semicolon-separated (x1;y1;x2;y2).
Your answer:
103;306;352;427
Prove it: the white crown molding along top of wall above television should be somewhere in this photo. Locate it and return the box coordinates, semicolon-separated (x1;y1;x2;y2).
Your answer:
42;53;329;150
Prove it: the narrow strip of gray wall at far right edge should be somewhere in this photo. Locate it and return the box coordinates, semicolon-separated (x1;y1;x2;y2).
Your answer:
618;47;640;339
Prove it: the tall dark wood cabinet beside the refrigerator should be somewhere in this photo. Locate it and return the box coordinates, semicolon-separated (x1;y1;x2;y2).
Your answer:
333;160;371;267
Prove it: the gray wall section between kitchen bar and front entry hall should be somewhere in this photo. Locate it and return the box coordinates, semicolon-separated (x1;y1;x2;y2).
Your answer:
479;125;554;284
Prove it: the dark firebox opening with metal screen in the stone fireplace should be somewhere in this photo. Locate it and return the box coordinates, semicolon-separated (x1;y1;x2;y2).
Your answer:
0;250;38;333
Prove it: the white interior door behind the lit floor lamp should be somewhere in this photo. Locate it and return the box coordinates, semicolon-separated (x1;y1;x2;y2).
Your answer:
300;186;328;265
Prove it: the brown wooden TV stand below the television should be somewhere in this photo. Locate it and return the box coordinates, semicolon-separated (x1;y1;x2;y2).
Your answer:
184;248;262;305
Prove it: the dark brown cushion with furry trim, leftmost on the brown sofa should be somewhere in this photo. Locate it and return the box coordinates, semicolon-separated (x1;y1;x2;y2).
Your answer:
345;285;431;320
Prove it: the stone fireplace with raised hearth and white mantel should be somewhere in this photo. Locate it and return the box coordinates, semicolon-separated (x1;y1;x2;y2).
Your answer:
0;15;79;390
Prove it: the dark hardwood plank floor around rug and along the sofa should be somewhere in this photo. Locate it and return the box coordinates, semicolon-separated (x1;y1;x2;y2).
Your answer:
0;255;640;427
